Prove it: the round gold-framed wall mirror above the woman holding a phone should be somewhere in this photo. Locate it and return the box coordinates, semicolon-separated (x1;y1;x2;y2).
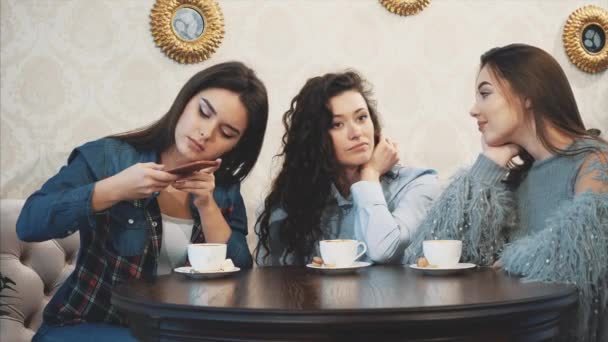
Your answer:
150;0;224;64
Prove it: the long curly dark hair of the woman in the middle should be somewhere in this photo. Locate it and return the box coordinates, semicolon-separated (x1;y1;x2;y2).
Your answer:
254;70;380;265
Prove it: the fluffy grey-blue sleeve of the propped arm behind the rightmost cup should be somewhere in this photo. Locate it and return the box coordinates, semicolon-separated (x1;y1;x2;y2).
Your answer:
403;155;518;265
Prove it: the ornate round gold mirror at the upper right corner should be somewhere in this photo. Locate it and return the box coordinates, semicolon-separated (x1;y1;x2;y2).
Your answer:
562;5;608;73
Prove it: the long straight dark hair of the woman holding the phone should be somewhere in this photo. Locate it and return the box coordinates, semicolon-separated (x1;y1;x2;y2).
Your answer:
110;62;268;184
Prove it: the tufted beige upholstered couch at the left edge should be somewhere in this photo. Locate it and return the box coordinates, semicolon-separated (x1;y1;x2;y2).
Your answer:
0;199;80;342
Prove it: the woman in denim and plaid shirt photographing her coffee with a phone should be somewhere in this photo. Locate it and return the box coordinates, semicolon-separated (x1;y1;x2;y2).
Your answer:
17;62;268;341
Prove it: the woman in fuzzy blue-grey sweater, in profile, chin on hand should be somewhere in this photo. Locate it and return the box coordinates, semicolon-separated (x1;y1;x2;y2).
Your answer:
403;44;608;341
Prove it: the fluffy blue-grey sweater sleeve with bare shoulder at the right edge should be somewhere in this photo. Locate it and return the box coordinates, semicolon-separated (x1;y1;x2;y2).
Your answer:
500;150;608;341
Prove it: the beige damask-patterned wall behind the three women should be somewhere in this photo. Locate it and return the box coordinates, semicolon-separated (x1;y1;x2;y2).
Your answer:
0;0;608;240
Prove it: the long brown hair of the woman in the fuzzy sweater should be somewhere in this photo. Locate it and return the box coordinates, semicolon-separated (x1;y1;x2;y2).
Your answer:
479;44;603;186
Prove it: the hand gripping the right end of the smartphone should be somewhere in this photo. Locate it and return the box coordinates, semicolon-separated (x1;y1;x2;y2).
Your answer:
173;159;222;208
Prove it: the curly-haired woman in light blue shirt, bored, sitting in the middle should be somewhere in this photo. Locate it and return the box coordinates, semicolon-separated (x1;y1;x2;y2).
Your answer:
255;71;438;265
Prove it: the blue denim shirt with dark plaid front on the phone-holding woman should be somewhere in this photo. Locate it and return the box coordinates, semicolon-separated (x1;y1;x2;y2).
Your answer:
17;138;252;324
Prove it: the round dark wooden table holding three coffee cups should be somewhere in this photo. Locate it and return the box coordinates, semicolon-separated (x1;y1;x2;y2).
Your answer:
112;266;577;341
